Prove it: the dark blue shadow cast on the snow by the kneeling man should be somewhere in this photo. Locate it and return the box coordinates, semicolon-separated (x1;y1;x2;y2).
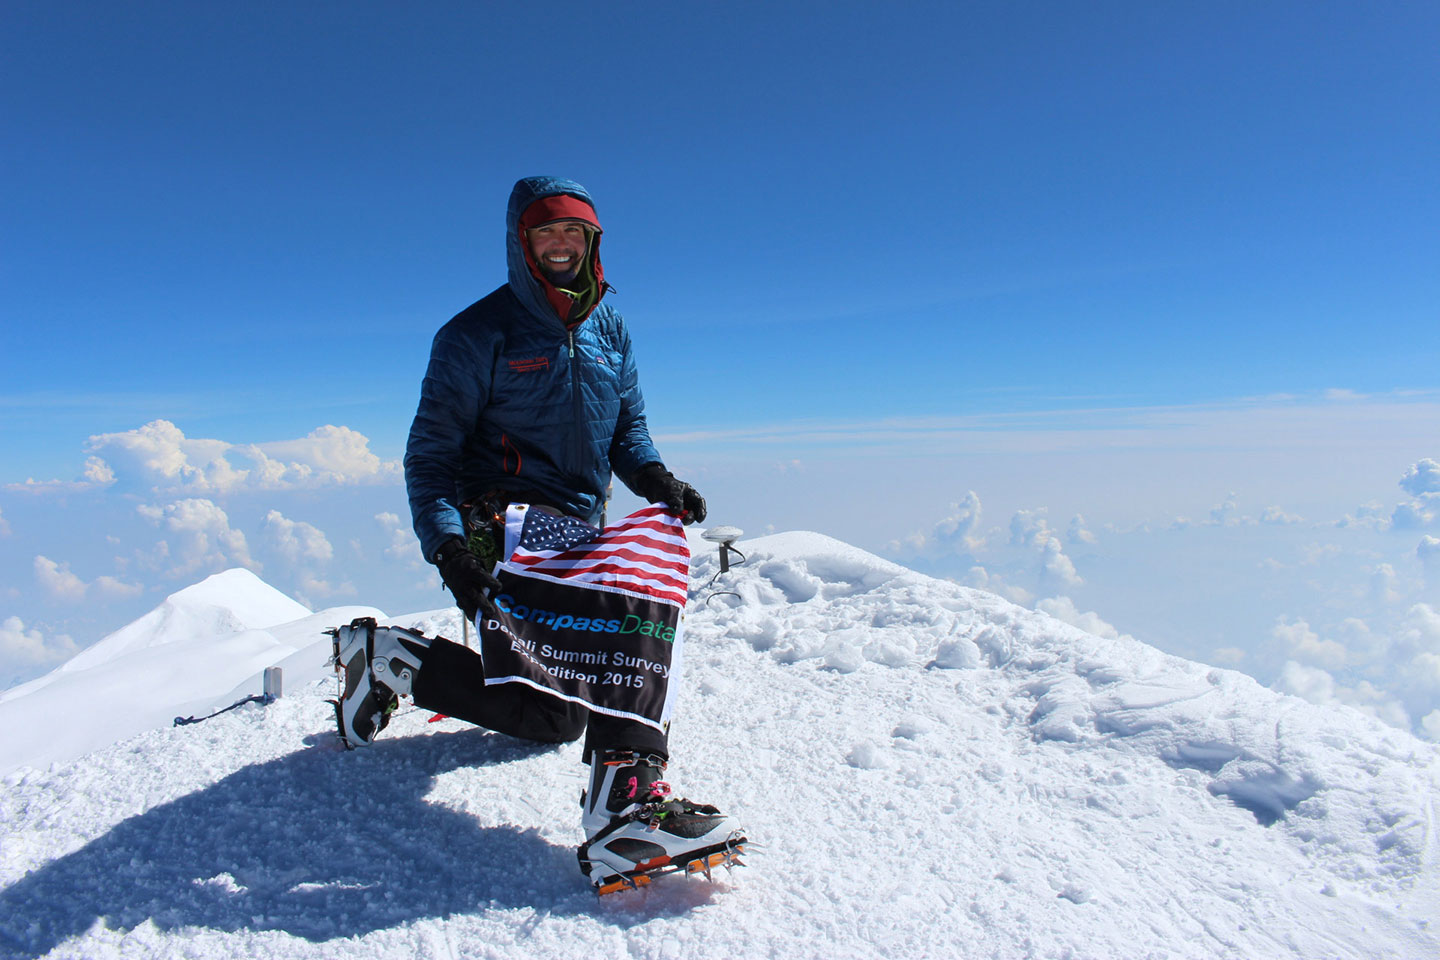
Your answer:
0;730;708;956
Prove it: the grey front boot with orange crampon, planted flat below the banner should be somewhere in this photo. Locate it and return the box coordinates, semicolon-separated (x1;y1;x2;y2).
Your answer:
579;750;746;894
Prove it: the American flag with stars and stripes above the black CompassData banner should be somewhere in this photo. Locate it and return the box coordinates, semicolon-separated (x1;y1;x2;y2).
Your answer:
505;505;690;607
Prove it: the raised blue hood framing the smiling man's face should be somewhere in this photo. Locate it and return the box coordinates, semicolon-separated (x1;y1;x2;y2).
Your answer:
505;177;606;327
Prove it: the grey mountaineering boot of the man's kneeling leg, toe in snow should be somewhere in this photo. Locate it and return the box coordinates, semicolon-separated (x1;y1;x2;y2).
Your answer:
330;616;431;750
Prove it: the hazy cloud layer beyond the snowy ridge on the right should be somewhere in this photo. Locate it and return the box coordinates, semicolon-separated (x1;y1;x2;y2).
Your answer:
888;458;1440;738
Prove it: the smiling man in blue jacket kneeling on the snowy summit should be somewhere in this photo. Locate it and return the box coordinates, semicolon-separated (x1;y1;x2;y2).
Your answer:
337;177;739;891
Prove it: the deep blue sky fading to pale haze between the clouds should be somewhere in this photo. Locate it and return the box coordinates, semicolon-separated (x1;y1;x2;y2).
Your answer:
0;3;1440;723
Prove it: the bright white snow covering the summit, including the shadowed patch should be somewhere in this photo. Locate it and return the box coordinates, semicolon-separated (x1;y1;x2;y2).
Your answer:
0;534;1440;960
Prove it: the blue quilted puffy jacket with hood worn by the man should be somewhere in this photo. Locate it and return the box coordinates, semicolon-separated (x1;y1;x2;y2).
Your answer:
405;177;660;561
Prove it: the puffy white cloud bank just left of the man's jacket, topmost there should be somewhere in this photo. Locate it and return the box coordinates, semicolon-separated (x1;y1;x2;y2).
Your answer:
85;420;402;494
